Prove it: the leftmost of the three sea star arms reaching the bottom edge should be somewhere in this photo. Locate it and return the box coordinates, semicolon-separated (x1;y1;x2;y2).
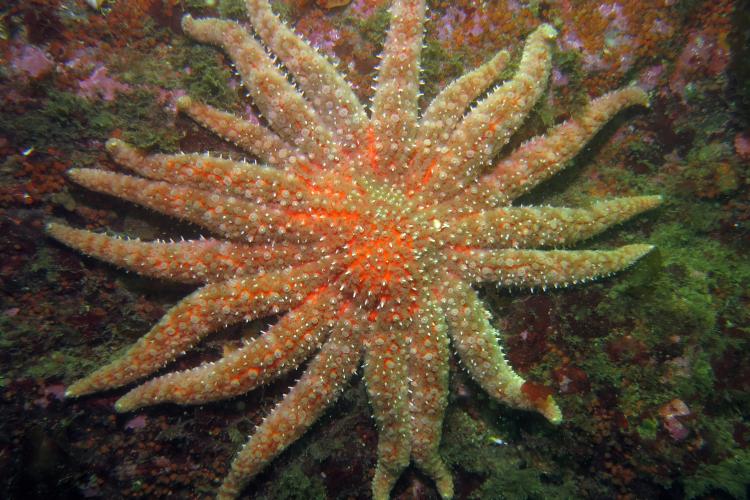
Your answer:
218;314;361;500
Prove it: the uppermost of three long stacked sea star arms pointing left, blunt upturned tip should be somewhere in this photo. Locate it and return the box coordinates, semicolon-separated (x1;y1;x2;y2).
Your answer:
107;139;307;205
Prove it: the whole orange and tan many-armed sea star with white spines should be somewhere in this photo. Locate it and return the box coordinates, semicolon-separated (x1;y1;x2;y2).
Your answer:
48;0;660;499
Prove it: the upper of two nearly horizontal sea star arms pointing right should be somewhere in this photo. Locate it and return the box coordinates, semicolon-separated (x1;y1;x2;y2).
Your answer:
445;196;662;248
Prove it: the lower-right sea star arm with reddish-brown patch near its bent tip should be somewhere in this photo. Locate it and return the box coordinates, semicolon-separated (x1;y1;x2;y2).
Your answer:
441;277;562;423
